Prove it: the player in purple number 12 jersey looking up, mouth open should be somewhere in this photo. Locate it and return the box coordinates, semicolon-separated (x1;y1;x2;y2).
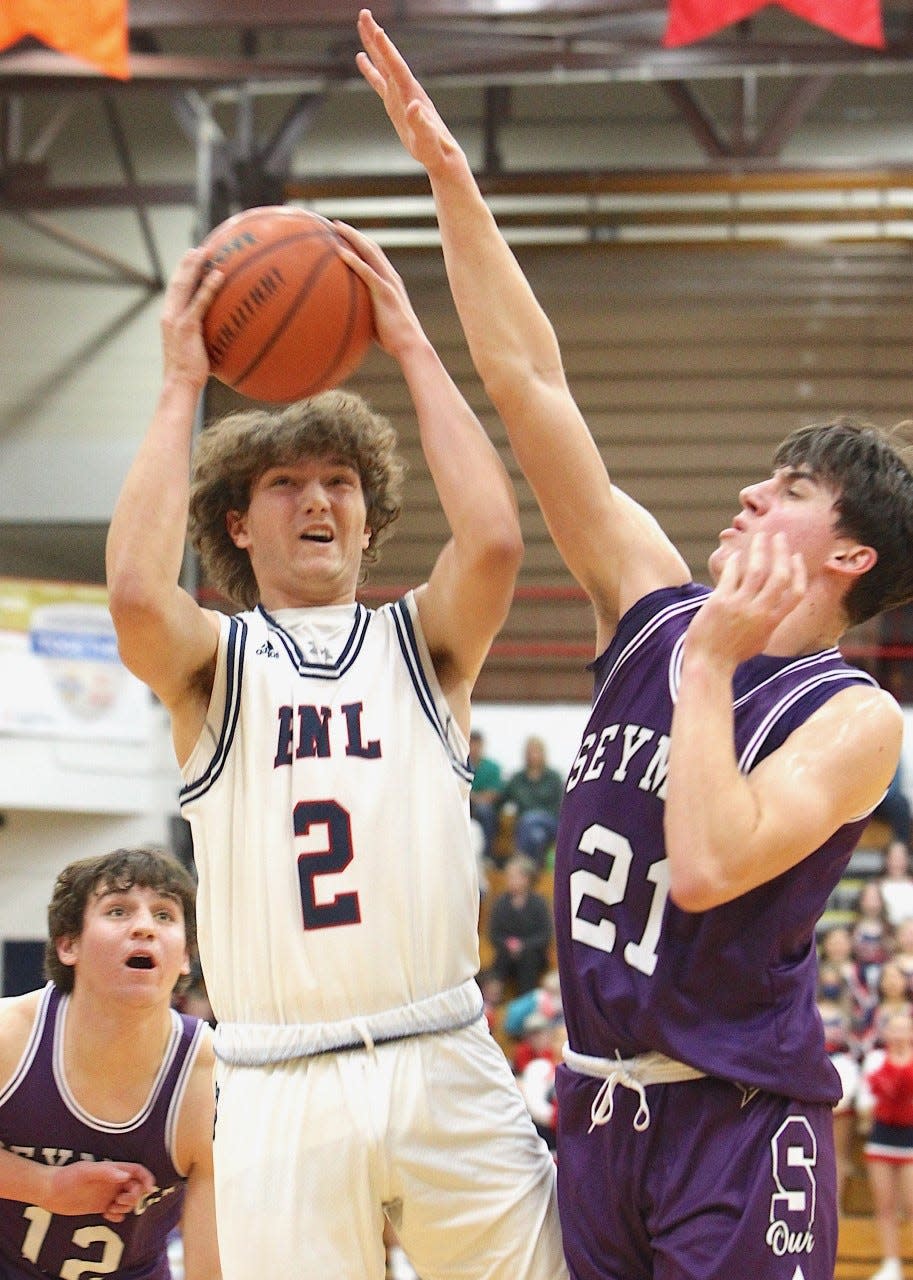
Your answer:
0;847;220;1280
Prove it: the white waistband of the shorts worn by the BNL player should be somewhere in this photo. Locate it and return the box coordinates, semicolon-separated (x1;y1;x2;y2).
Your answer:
214;978;483;1066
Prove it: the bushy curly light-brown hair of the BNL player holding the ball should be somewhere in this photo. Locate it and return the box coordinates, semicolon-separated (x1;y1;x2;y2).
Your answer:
190;390;405;609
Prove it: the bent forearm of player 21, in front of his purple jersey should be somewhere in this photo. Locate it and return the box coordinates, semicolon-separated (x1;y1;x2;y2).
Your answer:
663;650;759;911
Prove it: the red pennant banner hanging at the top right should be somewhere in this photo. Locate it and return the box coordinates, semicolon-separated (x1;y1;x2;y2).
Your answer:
663;0;885;49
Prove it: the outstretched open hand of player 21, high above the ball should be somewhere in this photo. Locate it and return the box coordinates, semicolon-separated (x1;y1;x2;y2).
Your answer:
355;9;460;174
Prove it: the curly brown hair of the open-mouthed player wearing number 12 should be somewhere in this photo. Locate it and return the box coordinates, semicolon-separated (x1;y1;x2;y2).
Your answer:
45;845;196;993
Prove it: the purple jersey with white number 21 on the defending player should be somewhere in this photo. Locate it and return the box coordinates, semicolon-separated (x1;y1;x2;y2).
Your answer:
554;584;875;1103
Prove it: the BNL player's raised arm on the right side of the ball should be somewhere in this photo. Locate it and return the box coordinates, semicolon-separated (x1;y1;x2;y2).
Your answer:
337;224;522;731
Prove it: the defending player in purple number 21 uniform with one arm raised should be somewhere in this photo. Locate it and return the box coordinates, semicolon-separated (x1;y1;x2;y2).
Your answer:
359;10;913;1280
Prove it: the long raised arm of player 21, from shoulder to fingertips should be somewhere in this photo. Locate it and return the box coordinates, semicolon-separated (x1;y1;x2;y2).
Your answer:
357;10;689;643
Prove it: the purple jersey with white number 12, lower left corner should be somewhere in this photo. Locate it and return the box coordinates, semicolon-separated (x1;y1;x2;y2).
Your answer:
0;983;202;1280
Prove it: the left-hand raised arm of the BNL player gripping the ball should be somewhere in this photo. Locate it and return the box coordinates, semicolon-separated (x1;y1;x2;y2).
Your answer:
106;250;220;759
